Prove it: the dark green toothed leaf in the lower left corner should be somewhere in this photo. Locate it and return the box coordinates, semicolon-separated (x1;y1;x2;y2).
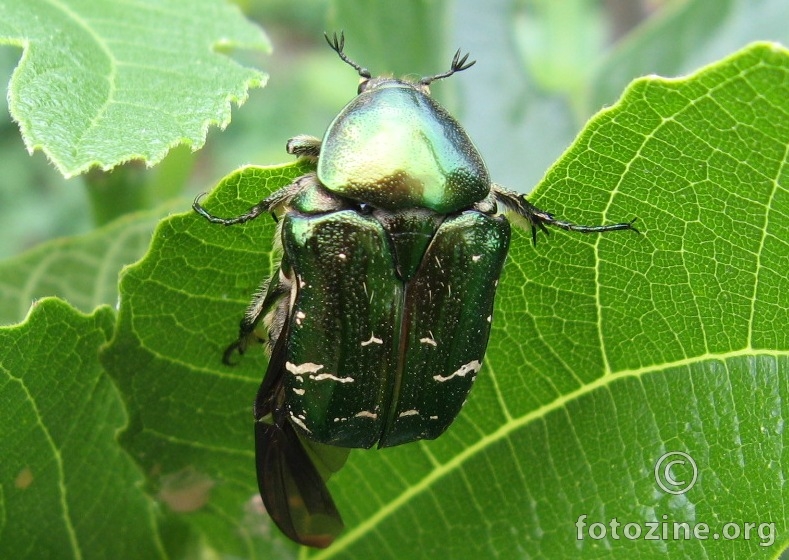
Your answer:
0;299;164;559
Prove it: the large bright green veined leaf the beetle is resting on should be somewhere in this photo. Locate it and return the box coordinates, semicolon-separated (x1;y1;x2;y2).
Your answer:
104;44;789;558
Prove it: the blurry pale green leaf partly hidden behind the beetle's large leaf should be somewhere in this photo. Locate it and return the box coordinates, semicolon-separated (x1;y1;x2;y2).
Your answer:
0;201;179;324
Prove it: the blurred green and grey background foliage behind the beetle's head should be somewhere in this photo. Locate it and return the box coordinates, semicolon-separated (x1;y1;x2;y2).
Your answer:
0;0;789;258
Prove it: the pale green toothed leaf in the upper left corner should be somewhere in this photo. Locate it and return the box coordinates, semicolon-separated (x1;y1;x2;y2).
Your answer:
0;0;270;176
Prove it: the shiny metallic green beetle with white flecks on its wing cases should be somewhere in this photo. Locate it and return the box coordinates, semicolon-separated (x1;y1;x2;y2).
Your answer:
194;34;635;547
